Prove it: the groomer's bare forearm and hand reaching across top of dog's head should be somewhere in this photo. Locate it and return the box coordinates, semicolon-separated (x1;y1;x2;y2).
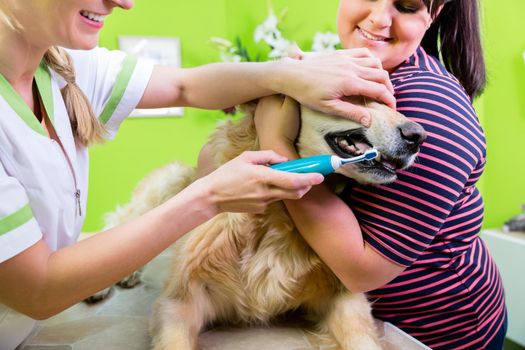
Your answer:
139;49;395;121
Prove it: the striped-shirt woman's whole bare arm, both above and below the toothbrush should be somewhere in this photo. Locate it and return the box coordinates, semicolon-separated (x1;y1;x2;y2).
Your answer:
256;97;405;292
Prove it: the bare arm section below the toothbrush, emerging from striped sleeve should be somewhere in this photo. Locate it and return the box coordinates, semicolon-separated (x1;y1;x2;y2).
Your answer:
284;184;405;292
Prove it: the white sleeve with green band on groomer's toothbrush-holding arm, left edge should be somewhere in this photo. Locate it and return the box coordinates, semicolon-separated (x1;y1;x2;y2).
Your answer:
0;163;42;263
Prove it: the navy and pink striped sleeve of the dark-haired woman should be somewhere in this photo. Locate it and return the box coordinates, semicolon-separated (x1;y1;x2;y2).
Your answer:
343;72;485;266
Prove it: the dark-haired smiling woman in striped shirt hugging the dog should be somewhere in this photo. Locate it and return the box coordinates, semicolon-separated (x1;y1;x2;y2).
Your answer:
256;0;507;349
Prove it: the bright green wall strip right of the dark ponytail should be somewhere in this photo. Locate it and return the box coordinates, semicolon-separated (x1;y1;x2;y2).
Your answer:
482;0;525;227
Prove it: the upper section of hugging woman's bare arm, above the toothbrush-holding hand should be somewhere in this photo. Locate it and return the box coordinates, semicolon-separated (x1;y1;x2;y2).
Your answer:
254;95;300;158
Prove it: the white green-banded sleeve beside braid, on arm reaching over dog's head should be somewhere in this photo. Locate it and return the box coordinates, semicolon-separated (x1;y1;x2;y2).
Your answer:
62;48;154;138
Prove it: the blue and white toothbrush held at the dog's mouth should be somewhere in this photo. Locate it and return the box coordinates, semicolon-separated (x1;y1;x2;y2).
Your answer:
270;148;379;176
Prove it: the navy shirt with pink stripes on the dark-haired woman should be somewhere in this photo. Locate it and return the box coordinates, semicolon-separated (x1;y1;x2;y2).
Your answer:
343;48;506;349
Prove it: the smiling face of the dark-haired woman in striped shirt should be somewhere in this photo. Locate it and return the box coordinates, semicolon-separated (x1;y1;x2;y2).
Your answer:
337;0;432;71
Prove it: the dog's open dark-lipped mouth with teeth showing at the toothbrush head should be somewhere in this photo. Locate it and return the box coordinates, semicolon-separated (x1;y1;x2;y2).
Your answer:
325;128;406;175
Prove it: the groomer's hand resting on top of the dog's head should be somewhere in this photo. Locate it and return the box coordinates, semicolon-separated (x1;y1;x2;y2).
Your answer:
277;48;396;126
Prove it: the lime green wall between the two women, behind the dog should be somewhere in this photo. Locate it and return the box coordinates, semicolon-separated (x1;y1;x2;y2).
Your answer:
84;0;338;232
